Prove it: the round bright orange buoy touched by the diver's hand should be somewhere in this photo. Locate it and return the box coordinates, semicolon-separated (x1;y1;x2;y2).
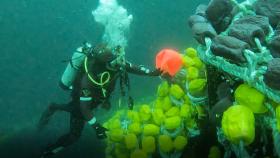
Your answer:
156;49;183;76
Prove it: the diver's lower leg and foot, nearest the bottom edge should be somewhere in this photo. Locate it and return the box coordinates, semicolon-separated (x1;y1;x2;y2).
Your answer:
42;114;85;158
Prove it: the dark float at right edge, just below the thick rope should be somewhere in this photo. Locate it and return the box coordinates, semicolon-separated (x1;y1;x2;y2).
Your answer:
264;58;280;90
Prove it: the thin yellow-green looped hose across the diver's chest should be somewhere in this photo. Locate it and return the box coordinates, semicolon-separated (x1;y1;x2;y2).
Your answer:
84;57;111;97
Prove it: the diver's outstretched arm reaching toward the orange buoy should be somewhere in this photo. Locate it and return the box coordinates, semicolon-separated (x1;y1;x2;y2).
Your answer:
125;62;161;76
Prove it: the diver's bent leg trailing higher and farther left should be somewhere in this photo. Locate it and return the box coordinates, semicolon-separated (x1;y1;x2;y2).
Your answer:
38;102;72;130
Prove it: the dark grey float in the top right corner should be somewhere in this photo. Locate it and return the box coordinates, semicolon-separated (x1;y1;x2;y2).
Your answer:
253;0;280;28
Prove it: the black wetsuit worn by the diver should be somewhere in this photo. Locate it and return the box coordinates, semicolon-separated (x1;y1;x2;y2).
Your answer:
41;56;160;154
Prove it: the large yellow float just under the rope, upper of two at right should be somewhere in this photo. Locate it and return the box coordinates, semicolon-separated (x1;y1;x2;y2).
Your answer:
234;84;267;114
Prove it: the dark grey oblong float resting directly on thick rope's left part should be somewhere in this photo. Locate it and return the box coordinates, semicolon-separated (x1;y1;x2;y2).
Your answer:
211;35;249;64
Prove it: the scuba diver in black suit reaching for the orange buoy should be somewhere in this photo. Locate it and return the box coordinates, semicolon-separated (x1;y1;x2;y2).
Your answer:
38;43;161;158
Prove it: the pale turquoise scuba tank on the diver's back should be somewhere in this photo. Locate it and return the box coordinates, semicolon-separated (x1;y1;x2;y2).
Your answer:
59;42;92;90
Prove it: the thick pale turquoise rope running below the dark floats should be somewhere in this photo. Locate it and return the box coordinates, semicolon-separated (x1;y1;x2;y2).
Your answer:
197;38;280;102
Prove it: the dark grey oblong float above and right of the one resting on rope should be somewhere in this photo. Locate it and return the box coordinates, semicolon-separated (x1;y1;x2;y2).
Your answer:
228;24;265;47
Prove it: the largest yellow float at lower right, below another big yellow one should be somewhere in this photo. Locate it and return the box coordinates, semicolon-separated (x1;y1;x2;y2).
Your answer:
222;105;255;145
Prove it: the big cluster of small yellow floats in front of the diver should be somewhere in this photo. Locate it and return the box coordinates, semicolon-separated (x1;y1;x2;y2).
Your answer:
104;48;205;158
